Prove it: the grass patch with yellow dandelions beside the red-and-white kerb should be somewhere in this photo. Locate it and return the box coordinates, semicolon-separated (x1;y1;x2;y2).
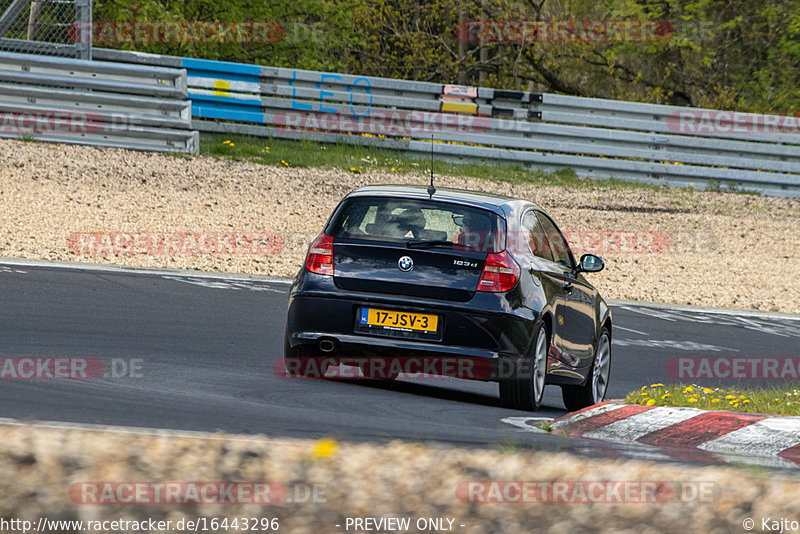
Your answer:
625;383;800;415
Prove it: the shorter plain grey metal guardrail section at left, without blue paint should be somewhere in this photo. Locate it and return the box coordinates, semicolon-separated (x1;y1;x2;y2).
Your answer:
0;53;199;154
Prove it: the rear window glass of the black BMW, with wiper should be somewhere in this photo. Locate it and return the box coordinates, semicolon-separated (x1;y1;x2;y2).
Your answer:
327;197;505;252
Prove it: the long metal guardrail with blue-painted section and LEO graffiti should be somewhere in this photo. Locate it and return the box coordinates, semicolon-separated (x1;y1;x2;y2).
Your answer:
94;48;800;197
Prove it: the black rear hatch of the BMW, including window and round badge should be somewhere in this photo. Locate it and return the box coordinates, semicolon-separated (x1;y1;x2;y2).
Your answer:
326;197;505;301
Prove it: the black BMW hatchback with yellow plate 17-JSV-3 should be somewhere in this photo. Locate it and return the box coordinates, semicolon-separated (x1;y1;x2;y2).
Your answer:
284;186;611;410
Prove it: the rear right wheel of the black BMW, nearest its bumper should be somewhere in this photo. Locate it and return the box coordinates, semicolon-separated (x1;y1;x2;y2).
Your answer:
499;324;550;411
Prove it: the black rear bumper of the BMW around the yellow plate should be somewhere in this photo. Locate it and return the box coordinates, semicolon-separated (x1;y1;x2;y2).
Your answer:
287;273;538;376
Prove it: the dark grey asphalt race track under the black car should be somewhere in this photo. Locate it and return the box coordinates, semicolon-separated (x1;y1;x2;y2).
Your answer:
0;263;800;468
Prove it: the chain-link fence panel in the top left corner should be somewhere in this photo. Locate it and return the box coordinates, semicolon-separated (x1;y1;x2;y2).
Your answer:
0;0;92;59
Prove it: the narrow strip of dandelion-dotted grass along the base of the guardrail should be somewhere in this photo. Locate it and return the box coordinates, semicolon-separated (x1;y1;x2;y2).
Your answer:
200;134;670;191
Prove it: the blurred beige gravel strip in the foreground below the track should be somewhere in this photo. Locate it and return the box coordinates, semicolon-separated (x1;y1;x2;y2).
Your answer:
0;424;800;534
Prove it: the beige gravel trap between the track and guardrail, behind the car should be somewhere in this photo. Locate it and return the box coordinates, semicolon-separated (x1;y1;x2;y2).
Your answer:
0;141;800;313
